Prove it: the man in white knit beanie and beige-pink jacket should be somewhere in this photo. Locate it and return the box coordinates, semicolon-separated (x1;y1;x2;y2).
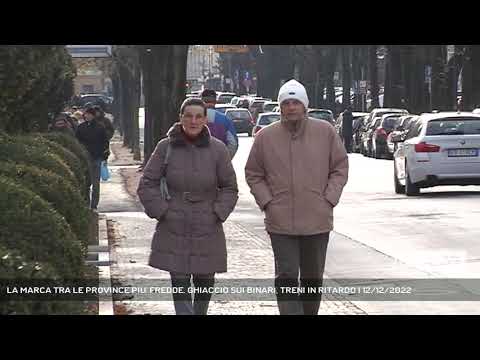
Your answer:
245;80;348;315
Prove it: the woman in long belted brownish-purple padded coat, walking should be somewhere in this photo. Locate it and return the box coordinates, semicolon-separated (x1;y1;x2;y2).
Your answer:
137;98;238;315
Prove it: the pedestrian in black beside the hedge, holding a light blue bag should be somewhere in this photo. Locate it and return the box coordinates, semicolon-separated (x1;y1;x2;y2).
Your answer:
76;108;110;210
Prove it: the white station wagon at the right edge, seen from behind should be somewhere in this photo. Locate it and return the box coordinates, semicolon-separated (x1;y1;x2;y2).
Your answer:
394;112;480;196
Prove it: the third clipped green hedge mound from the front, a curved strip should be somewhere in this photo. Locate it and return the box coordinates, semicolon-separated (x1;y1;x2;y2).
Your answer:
0;161;90;248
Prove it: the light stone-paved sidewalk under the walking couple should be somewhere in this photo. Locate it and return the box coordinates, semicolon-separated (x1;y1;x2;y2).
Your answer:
99;137;366;315
